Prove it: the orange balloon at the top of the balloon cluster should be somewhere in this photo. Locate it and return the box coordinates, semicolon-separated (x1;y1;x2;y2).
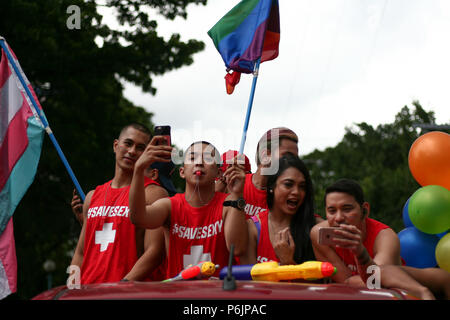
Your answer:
408;131;450;190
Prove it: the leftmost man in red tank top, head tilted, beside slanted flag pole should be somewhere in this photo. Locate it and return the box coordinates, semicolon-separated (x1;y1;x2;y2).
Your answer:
68;124;167;285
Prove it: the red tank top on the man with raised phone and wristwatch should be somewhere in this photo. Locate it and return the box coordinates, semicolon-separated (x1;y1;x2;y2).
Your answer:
167;192;229;278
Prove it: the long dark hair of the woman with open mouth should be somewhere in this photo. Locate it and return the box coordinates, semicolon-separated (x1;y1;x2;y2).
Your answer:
267;154;316;263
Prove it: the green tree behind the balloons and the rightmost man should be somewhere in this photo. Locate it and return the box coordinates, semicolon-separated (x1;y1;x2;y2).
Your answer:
305;101;446;232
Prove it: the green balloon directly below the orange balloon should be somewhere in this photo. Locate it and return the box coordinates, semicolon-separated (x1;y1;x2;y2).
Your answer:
408;185;450;234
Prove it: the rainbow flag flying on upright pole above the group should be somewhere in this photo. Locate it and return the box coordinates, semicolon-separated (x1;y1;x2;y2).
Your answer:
208;0;280;94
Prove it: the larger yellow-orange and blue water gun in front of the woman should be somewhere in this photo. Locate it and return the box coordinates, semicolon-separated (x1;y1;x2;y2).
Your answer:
219;261;337;281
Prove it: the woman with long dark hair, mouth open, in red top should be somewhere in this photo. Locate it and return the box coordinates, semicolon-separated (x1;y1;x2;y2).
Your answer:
240;154;316;265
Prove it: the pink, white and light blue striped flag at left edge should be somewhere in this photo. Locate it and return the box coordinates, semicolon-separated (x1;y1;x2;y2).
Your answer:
0;38;44;299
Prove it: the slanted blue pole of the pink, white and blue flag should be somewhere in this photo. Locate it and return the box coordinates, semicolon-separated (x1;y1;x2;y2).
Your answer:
0;36;85;202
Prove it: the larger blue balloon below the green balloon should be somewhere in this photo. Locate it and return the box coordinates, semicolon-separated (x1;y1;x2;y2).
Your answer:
398;227;439;268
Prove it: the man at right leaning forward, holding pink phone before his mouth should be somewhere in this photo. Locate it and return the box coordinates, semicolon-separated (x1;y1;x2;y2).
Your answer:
311;179;450;299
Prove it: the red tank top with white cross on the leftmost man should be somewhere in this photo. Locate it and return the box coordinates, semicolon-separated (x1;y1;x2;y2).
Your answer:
81;178;158;284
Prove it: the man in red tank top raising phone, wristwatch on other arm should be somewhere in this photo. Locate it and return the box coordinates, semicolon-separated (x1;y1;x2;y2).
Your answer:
129;141;248;278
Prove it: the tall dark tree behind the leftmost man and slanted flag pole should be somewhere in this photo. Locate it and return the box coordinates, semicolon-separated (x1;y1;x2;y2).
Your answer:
0;0;206;299
